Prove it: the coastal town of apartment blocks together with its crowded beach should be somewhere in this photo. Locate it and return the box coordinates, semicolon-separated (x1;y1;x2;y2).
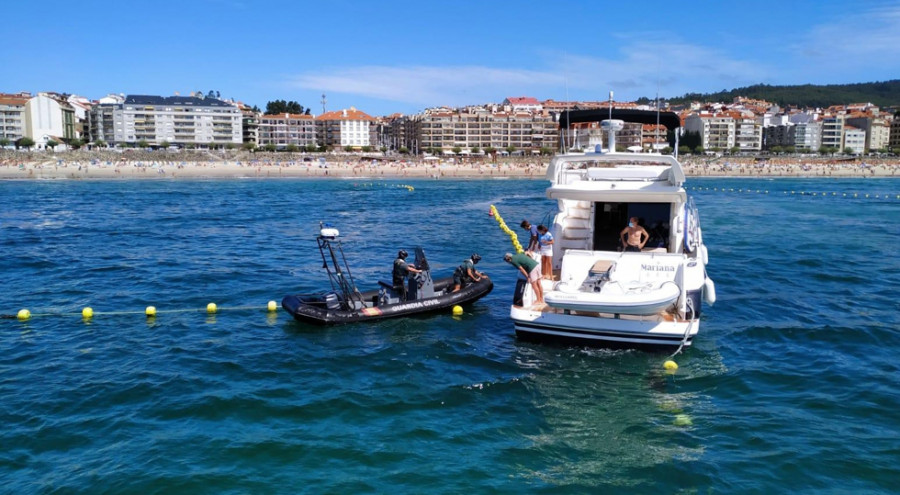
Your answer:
0;91;900;178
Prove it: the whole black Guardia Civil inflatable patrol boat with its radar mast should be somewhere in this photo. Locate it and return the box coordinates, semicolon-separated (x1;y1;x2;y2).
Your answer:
281;225;494;325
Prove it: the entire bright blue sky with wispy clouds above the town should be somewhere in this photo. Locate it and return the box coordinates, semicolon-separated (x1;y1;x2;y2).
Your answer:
0;0;900;115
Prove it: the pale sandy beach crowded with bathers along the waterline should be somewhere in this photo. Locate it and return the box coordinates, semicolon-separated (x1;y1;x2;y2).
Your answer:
0;150;900;179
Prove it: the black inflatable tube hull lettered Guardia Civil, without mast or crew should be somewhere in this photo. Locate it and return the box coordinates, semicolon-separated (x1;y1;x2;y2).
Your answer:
281;277;494;325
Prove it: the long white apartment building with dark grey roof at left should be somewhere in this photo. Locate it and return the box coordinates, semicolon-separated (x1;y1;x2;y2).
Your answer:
102;95;242;146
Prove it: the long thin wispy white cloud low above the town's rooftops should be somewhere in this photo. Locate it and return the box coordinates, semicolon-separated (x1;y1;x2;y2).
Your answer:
288;38;766;107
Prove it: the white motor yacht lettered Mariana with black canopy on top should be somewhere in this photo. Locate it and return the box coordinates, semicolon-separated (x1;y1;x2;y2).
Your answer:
510;109;715;349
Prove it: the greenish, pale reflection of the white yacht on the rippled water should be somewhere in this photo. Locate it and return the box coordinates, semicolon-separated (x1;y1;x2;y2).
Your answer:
515;345;724;486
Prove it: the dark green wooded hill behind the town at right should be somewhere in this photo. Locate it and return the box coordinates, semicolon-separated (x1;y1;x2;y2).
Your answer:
638;79;900;108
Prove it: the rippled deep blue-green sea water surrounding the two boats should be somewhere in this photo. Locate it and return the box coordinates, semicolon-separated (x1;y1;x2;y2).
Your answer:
0;178;900;494
